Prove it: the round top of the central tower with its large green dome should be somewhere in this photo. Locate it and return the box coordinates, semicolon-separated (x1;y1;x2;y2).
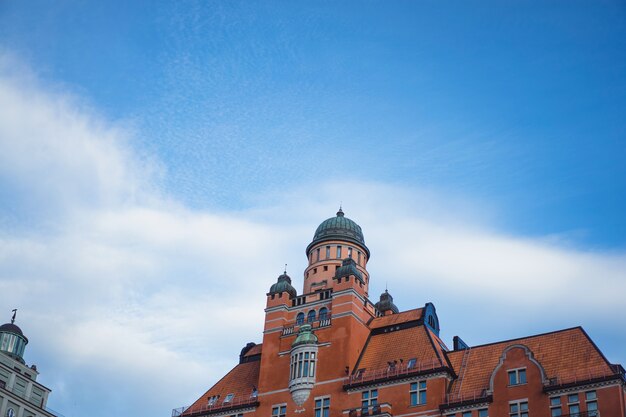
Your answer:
304;208;370;295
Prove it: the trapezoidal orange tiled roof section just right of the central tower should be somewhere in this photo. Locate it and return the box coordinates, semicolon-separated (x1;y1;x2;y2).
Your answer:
355;318;445;371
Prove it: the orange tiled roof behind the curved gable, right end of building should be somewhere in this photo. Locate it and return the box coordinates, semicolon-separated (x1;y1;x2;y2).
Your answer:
448;327;614;395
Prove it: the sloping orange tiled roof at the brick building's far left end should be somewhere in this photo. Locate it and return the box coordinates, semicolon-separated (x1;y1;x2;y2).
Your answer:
183;360;261;415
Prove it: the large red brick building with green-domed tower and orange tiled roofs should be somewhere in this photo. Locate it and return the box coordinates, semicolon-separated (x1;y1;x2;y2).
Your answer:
173;209;626;417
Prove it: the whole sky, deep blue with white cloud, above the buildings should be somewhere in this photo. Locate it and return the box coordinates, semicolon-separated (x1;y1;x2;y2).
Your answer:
0;1;626;417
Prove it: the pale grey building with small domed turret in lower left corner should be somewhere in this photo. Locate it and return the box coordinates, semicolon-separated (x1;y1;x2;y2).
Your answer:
0;310;58;417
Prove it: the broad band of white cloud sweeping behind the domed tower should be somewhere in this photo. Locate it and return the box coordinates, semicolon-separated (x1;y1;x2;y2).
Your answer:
0;58;626;417
